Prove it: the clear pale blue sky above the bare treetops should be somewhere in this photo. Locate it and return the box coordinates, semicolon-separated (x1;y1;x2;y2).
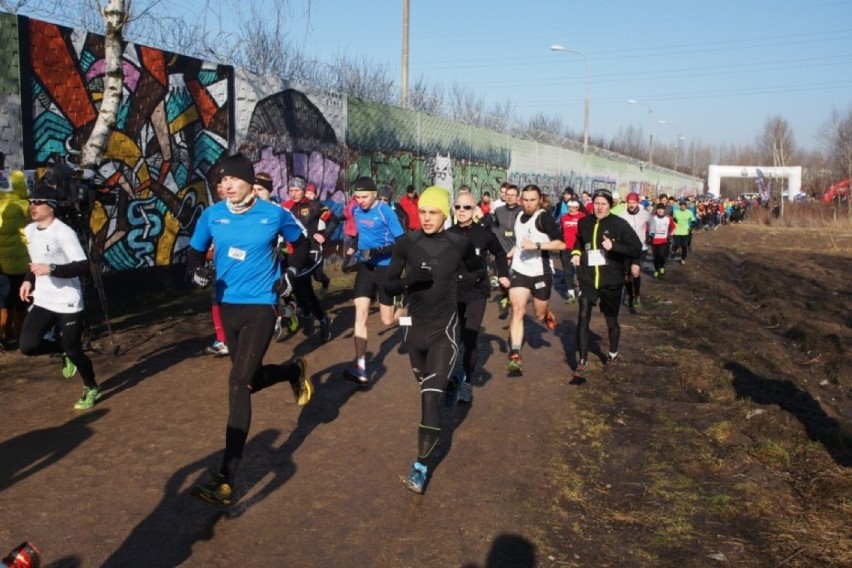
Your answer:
176;0;852;153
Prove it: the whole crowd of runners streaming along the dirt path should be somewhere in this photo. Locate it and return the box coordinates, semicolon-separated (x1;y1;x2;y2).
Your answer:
0;154;747;505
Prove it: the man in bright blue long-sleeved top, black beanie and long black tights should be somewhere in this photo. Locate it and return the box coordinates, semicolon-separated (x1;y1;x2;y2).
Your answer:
187;154;313;505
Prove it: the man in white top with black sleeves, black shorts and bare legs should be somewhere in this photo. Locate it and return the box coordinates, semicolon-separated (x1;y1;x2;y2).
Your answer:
506;185;565;373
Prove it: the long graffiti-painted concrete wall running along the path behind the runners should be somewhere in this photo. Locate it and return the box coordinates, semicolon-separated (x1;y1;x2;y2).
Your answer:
0;14;701;280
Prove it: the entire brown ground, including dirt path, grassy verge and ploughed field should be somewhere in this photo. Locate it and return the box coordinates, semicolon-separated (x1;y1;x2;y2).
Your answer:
0;225;852;567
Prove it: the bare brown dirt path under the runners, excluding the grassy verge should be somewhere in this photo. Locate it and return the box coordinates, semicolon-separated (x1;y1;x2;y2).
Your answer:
0;272;584;566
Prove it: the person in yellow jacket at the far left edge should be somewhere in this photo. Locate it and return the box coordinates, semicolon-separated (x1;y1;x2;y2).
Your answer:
0;170;30;340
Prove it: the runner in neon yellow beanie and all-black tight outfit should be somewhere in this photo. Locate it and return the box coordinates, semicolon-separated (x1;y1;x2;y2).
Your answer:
384;186;485;493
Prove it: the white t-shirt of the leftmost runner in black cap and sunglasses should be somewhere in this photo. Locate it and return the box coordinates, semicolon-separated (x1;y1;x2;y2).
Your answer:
24;219;86;314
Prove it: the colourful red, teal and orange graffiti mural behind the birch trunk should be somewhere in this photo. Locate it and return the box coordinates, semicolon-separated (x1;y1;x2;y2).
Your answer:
23;20;229;270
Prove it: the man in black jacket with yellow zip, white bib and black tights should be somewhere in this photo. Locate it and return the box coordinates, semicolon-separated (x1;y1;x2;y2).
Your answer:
571;189;642;378
